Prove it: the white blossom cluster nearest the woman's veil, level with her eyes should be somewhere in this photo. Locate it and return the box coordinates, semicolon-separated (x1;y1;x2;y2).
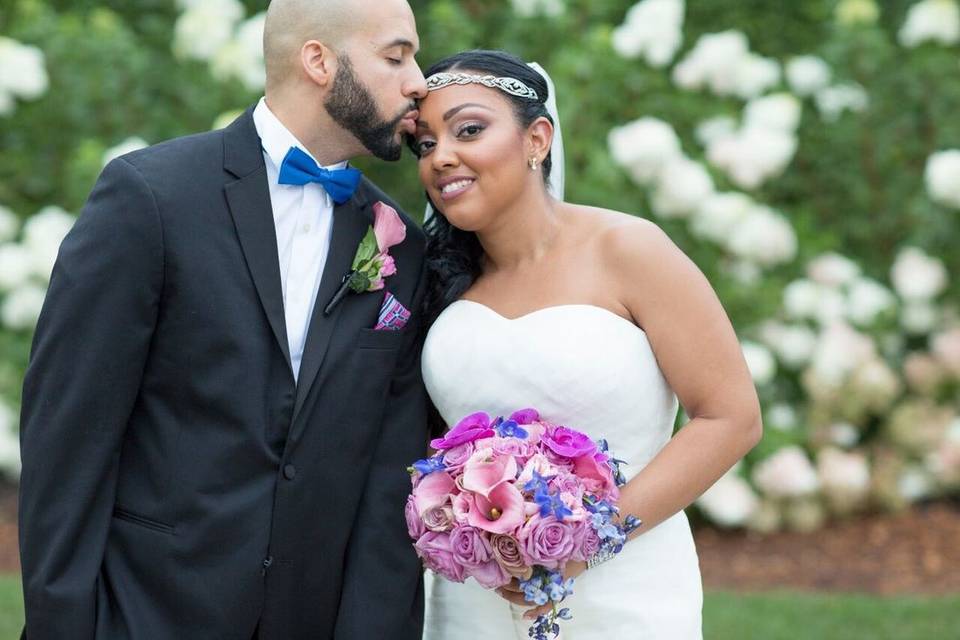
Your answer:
607;118;683;185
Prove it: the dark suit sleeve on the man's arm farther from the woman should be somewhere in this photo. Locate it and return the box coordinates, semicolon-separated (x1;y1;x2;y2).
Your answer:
20;158;163;640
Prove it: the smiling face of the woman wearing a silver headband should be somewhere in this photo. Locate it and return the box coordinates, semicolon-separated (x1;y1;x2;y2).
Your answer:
415;84;539;231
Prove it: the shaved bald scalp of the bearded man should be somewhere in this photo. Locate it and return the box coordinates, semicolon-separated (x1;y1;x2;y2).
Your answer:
263;0;412;89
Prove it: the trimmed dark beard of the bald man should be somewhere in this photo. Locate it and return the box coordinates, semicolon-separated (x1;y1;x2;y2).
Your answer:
323;55;416;160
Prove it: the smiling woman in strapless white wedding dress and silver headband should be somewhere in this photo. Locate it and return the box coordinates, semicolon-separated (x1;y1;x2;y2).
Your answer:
410;51;761;640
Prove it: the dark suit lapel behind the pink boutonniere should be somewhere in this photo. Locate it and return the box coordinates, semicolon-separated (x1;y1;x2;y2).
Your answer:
290;184;373;430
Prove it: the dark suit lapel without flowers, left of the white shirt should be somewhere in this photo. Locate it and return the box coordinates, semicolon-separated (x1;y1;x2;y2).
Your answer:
224;108;292;375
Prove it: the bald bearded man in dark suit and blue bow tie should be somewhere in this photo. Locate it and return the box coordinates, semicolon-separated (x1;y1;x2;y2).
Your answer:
20;0;426;640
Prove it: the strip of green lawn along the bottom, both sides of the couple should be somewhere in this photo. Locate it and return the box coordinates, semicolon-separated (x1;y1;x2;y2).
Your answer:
0;576;960;640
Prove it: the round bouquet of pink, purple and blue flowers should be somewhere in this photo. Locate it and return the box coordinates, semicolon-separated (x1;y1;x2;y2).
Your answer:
406;409;640;640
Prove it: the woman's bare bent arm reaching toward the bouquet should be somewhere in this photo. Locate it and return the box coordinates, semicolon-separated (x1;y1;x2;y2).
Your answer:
603;219;762;537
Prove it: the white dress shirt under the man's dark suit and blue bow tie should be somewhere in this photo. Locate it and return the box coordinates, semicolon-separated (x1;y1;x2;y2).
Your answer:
253;98;347;380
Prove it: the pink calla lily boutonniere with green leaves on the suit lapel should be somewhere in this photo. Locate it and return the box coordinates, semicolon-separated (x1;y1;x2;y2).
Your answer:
323;202;407;316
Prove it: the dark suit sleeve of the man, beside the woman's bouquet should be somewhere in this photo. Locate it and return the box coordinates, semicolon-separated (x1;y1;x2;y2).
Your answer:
334;256;427;640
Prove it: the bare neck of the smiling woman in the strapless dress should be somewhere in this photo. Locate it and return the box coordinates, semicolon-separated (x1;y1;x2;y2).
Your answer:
477;188;560;271
